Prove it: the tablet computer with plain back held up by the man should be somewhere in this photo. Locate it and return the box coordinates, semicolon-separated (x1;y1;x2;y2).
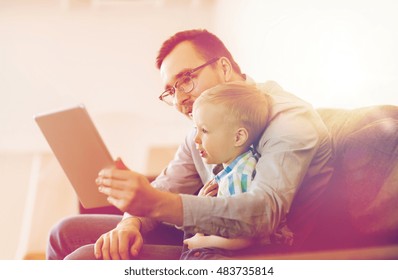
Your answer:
34;105;114;208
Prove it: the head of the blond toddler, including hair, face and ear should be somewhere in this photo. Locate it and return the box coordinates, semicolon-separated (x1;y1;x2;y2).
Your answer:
193;82;270;164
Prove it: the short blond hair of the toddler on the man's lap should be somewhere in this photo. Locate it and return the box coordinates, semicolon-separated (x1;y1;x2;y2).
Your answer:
193;82;271;146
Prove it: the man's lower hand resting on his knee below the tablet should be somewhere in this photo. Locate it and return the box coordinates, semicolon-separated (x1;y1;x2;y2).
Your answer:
94;217;143;260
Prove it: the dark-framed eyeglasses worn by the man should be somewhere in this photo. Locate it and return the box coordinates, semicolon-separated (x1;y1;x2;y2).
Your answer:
159;57;218;106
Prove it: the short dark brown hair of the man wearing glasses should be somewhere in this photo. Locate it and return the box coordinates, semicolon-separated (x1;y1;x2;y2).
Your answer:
156;29;242;75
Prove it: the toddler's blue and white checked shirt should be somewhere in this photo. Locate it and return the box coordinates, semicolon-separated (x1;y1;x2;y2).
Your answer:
215;150;257;197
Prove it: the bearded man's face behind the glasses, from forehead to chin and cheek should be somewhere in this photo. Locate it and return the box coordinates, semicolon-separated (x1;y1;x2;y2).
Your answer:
160;42;225;118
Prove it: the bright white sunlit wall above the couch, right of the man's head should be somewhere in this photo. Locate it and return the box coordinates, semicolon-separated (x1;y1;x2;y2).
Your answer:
215;0;398;108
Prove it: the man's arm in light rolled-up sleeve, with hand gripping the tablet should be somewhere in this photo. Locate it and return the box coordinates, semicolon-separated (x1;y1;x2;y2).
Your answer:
101;94;326;241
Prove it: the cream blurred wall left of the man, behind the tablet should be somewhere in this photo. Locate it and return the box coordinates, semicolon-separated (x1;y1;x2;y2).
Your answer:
0;0;213;259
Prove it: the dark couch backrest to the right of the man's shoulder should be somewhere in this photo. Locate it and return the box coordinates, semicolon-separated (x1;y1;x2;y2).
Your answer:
316;105;398;247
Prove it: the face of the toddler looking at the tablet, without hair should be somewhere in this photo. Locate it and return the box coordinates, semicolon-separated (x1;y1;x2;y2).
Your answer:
193;103;239;164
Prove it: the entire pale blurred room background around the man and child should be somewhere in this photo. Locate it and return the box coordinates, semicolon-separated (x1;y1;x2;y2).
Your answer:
0;0;398;259
